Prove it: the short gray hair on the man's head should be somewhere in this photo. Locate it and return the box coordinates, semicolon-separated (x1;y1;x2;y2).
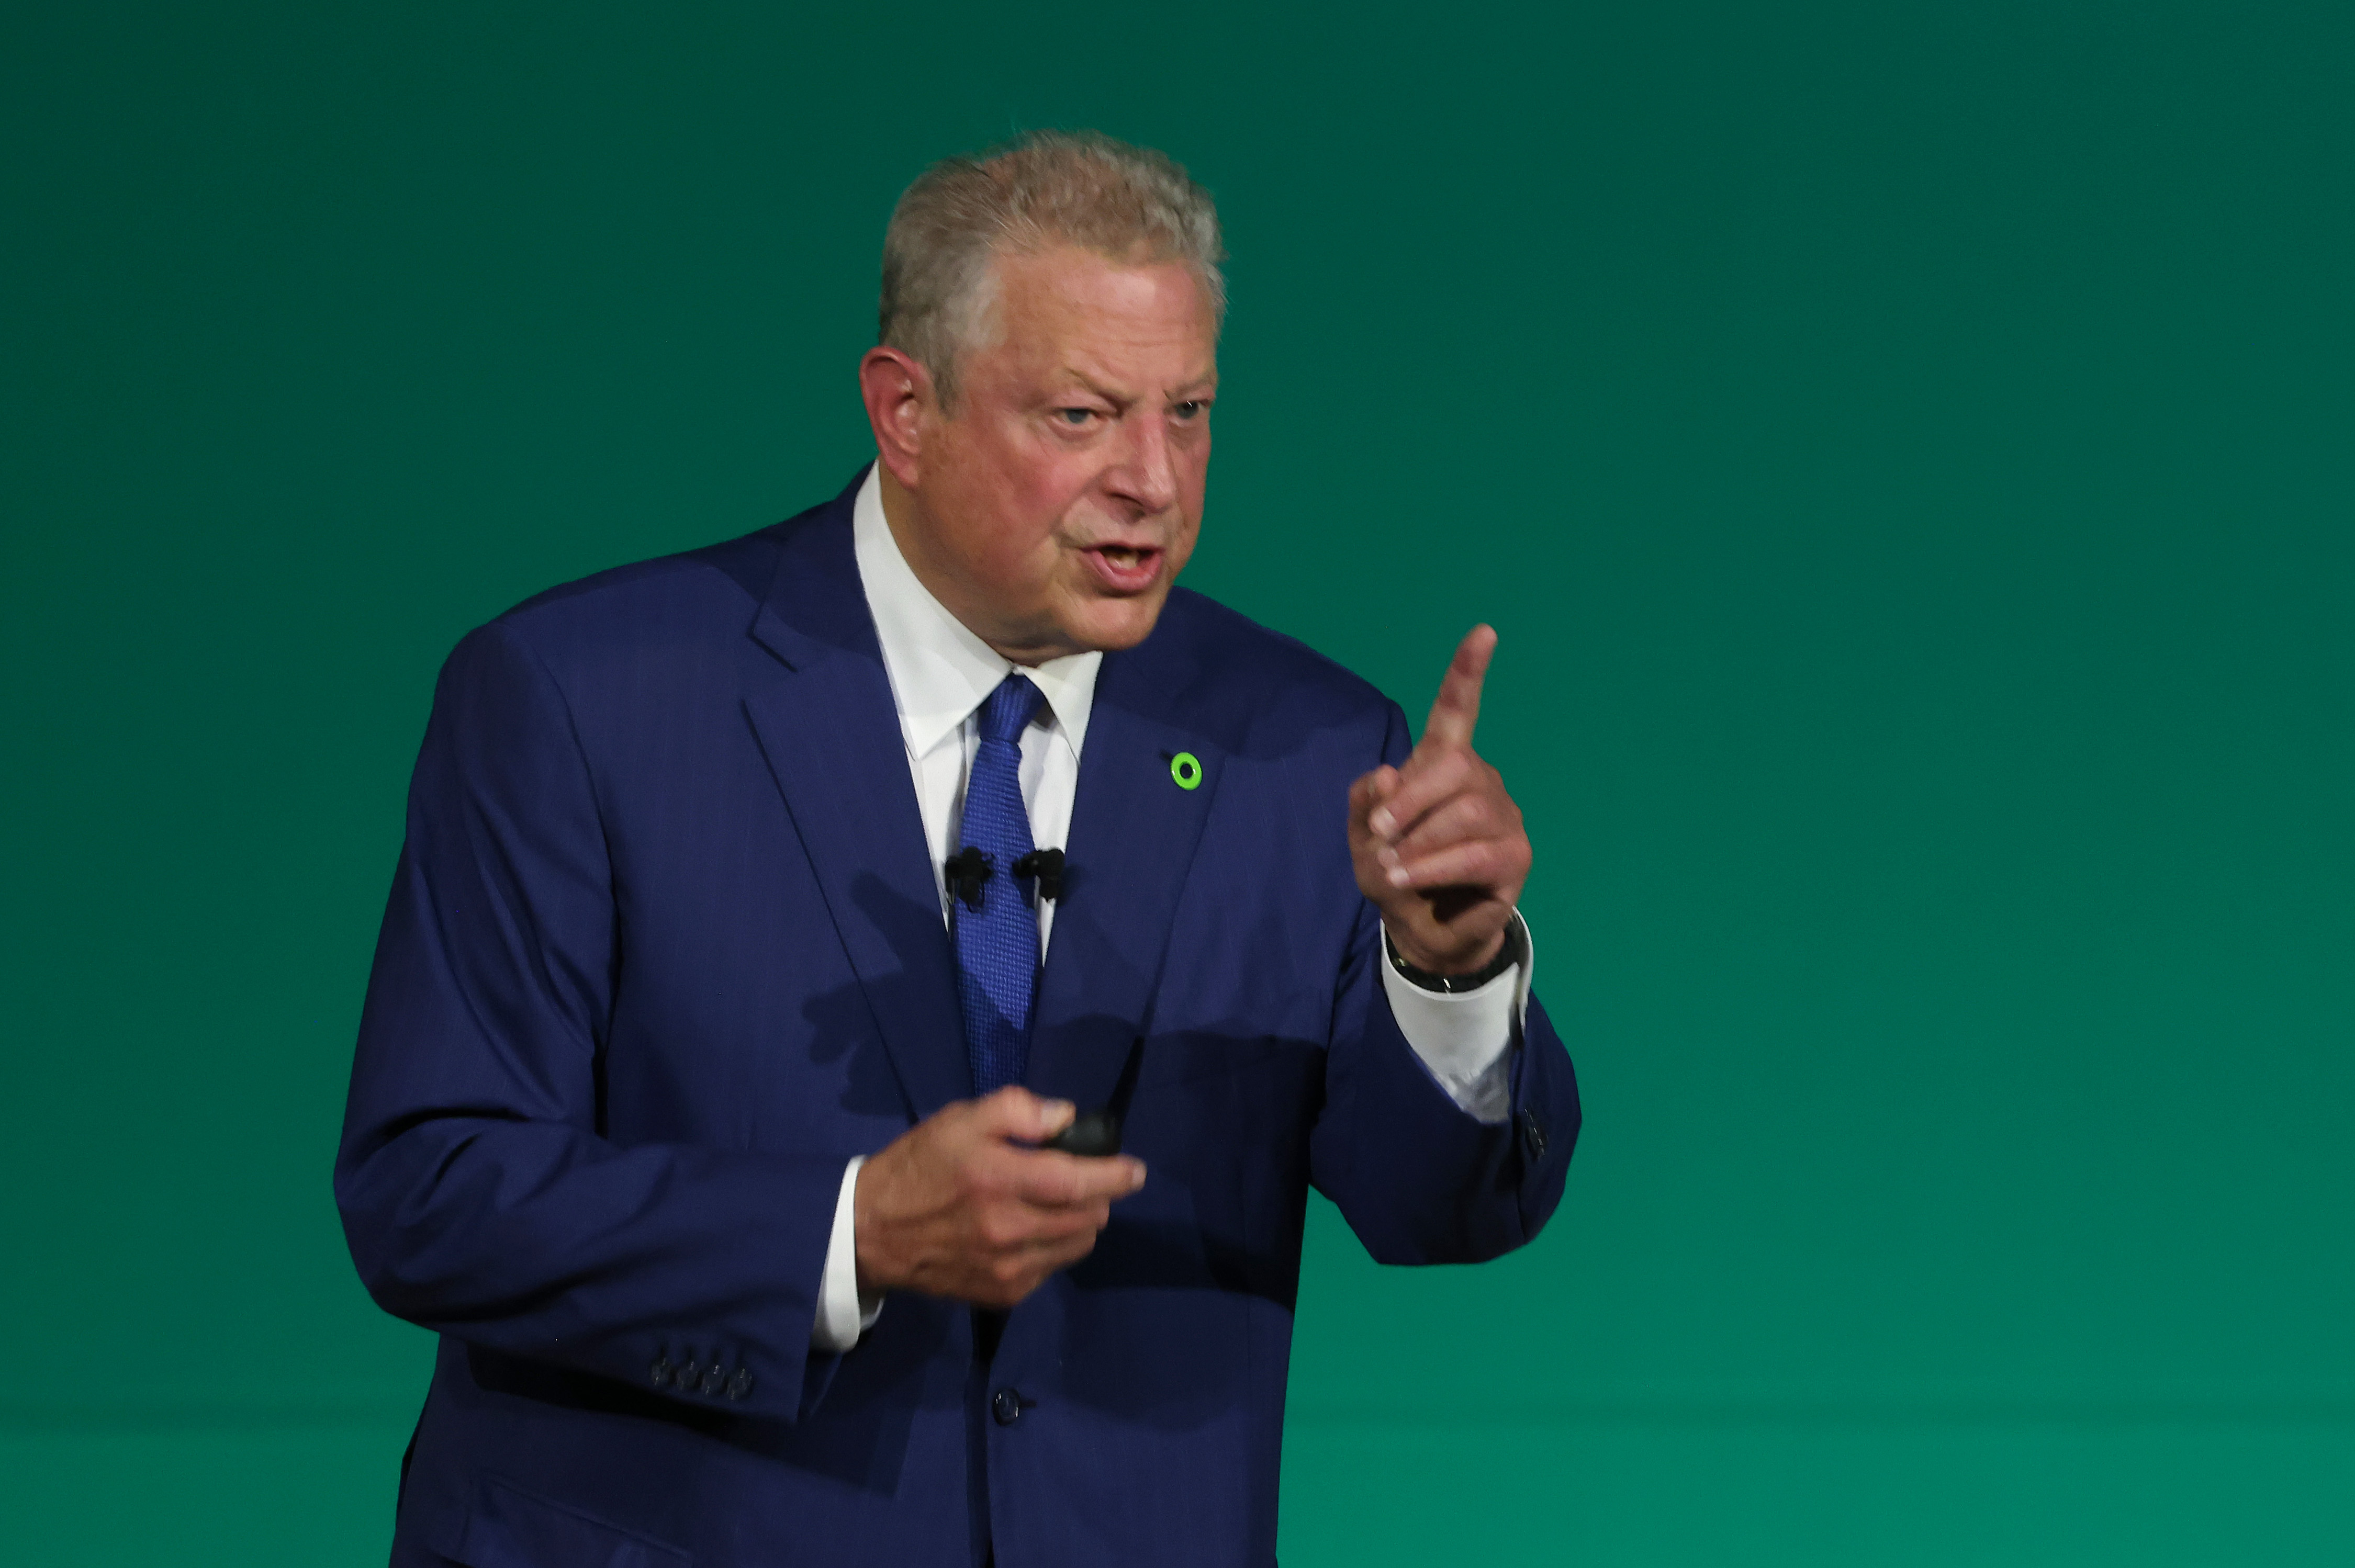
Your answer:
879;132;1227;410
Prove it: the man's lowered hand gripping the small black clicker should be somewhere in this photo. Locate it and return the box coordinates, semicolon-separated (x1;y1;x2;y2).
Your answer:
850;1083;1145;1307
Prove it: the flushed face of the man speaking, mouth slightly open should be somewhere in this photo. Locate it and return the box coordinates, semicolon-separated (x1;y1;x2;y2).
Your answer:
895;250;1218;664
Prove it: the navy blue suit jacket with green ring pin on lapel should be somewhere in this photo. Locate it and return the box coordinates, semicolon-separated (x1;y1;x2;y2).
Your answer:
334;471;1578;1568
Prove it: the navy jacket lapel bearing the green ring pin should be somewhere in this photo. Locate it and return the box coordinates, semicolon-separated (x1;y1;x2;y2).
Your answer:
1025;640;1225;1111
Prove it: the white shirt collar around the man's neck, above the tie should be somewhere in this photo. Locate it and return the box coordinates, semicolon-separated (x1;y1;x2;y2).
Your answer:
850;464;1105;758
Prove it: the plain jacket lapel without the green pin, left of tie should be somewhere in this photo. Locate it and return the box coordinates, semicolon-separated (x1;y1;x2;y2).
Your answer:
744;485;966;1121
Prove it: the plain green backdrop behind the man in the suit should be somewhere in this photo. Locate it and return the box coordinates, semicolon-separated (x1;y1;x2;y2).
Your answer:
0;0;2355;1568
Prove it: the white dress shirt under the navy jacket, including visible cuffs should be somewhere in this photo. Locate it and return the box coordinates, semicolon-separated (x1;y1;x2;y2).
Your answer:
810;469;1533;1351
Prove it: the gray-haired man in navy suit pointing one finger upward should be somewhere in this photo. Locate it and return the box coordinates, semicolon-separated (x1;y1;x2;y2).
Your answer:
337;137;1578;1568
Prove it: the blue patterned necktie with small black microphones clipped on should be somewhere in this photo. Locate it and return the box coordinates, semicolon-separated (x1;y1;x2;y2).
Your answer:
951;673;1046;1095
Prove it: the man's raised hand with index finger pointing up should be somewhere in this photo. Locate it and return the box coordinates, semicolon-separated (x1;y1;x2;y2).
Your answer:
1350;626;1529;975
